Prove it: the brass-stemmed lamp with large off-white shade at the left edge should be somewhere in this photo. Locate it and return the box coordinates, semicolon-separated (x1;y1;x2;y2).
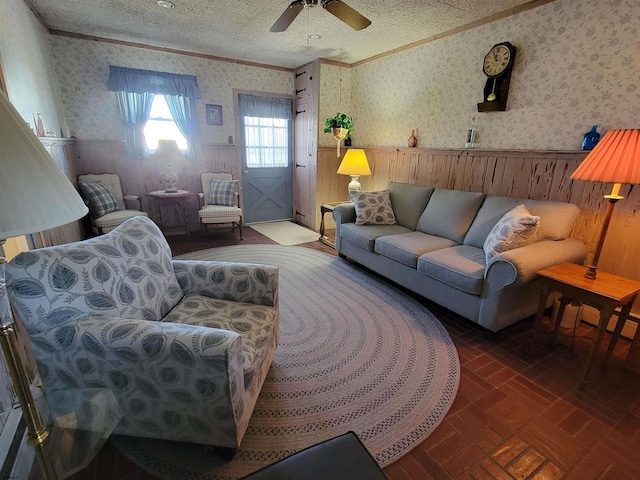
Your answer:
0;92;88;480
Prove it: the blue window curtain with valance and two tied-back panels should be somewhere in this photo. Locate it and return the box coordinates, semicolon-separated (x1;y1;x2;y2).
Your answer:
109;65;201;158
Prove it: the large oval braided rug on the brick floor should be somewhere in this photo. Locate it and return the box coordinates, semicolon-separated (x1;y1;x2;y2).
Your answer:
114;245;460;480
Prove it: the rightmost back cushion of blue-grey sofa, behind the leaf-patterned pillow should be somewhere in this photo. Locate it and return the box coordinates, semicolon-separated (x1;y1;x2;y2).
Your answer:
462;195;580;248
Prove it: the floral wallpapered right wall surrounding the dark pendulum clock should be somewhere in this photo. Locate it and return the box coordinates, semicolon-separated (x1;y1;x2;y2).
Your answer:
328;0;640;150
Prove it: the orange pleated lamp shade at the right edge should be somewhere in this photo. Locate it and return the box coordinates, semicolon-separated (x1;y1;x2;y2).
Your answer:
571;129;640;184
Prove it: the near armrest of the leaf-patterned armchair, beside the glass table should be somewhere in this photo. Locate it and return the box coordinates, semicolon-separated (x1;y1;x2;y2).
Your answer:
31;316;244;448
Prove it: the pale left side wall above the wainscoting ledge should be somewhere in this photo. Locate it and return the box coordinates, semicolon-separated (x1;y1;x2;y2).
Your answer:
0;0;62;136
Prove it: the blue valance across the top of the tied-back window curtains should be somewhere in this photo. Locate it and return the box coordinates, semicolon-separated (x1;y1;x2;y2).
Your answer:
109;65;201;99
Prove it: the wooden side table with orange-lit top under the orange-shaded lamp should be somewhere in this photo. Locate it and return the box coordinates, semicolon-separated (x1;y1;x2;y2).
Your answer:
531;263;640;384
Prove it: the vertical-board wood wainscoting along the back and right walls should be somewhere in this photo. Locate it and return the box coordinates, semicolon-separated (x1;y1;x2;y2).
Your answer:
60;140;640;313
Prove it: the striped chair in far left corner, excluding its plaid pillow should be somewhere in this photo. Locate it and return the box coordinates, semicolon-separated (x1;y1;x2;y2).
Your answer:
78;173;148;235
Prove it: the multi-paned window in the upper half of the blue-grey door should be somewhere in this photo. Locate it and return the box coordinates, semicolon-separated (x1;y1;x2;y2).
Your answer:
244;117;289;168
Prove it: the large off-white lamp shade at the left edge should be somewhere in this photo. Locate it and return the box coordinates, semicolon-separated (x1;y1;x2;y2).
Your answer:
0;92;89;240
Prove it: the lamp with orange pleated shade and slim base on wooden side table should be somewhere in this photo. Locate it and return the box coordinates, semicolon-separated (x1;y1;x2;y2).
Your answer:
571;129;640;279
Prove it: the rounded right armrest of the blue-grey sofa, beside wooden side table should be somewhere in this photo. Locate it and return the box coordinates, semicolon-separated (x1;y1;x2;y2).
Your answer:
485;238;587;288
